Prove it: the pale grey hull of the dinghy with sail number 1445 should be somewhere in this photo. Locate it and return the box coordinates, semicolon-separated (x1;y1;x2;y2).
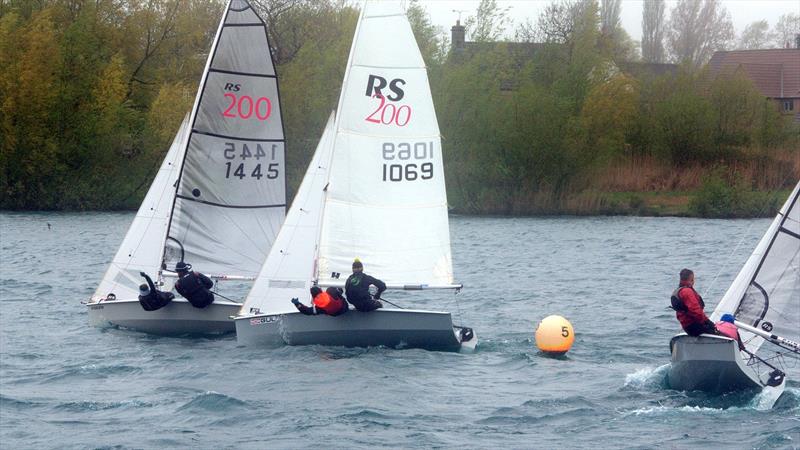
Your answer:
87;299;241;336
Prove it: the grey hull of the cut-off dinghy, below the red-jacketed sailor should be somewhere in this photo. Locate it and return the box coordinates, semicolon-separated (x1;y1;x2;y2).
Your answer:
667;334;766;392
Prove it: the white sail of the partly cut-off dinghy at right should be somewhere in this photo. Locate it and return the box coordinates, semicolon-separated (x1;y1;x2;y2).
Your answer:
711;183;800;352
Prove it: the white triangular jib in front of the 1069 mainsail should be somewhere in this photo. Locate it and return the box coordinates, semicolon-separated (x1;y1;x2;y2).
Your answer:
240;113;334;314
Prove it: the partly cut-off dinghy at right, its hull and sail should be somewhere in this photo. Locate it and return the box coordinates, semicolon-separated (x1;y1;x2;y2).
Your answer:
667;183;800;399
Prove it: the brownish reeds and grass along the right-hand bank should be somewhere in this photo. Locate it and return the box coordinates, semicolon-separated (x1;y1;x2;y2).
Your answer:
451;149;800;217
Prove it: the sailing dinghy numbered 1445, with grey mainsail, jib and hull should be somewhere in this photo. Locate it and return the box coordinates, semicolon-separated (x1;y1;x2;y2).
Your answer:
87;0;286;334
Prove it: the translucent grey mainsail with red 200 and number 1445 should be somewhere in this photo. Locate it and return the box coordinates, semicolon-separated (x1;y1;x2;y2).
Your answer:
162;0;286;276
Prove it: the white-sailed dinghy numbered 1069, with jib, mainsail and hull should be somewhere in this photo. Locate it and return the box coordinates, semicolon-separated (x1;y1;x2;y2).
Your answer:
235;1;477;351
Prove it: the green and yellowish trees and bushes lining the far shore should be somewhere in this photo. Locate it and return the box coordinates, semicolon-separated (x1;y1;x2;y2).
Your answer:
0;0;800;217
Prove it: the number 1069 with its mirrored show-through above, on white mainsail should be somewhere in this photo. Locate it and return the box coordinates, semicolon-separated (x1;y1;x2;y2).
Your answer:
383;142;433;181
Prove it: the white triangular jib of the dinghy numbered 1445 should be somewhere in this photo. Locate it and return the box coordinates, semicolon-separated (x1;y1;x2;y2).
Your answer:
94;114;189;298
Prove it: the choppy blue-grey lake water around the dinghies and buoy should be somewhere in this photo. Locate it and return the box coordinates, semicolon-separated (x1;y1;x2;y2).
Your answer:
0;213;800;448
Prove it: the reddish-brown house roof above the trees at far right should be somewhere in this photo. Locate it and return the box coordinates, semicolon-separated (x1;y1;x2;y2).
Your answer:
708;48;800;98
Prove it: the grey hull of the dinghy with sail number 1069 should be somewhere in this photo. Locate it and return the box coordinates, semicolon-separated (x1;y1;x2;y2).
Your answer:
236;309;461;351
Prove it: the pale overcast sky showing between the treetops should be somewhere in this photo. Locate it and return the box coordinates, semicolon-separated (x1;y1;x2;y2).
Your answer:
422;0;800;41
